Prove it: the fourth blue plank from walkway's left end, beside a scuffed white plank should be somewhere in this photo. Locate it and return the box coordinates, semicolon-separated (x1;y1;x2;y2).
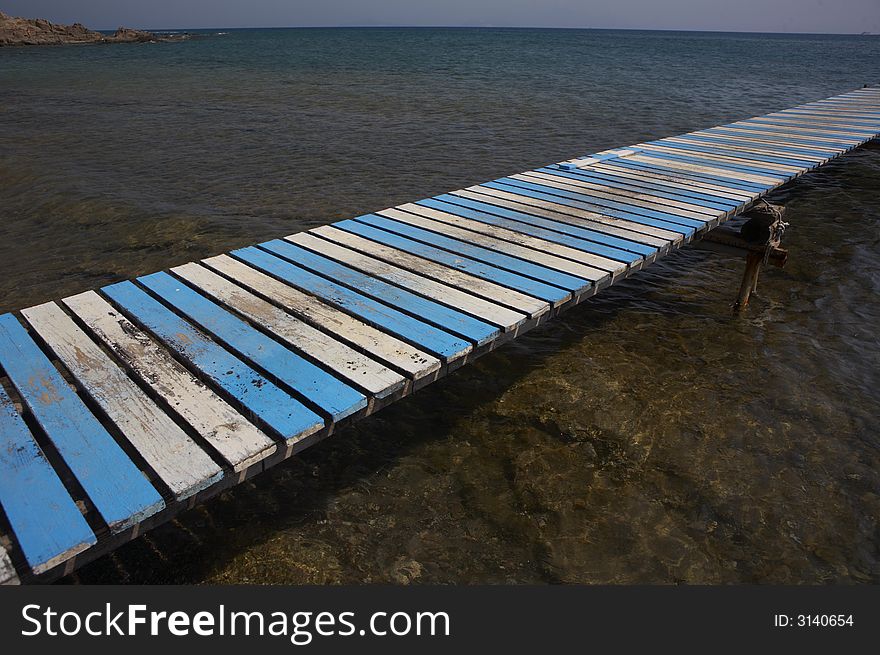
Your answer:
138;273;367;422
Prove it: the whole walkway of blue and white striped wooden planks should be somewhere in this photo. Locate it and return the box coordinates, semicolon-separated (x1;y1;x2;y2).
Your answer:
0;88;880;583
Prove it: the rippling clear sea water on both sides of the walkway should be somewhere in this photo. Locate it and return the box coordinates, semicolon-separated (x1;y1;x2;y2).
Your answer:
0;29;880;583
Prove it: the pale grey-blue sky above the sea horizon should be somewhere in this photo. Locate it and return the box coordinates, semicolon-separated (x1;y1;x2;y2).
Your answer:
0;0;880;34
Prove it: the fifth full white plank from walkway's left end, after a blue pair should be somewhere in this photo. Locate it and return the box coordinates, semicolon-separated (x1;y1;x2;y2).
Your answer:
285;232;528;332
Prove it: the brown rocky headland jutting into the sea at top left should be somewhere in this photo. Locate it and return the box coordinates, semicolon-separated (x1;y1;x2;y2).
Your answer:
0;12;170;47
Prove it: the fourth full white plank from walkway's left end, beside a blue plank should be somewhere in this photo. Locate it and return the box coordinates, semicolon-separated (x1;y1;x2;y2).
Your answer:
203;255;440;380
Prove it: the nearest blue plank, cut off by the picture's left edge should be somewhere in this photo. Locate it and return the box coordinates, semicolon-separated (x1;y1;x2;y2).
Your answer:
0;387;97;573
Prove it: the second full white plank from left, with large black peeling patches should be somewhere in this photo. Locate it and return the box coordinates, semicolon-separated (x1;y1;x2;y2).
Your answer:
62;291;276;471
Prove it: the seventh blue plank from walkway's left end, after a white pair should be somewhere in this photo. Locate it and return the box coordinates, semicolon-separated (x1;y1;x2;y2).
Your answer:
333;219;570;305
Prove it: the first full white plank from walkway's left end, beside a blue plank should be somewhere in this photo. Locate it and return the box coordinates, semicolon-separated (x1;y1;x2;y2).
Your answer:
22;302;223;500
